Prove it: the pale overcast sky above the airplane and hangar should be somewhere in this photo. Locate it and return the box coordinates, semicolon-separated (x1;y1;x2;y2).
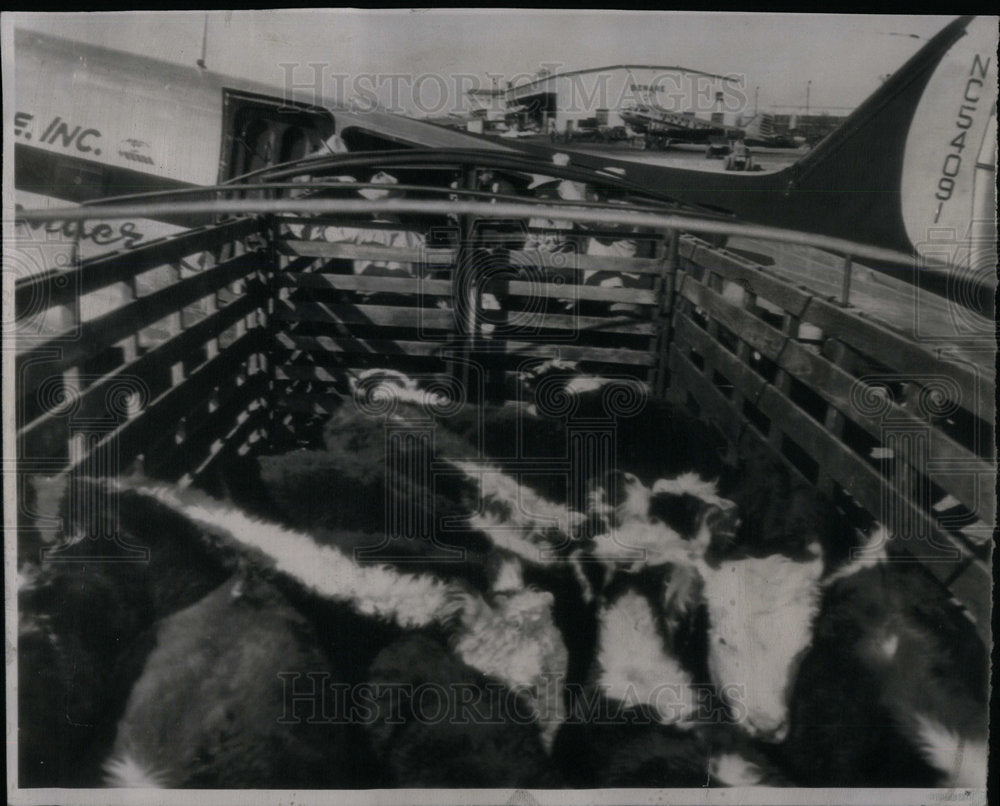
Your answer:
15;9;952;112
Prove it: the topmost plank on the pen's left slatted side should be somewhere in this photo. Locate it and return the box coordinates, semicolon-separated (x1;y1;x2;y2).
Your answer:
14;218;262;311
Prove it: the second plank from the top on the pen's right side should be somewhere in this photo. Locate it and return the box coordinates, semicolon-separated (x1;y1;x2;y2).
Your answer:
677;290;996;523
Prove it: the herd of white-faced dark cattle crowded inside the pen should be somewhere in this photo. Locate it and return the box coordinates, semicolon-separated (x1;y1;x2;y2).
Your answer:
18;362;989;789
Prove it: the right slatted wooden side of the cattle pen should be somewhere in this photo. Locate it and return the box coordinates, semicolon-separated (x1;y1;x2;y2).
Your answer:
668;236;996;644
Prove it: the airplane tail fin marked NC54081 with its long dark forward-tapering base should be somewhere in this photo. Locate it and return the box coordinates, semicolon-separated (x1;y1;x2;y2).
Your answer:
573;17;997;280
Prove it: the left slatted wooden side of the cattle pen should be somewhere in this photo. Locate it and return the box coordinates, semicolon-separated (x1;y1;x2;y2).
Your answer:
13;219;273;492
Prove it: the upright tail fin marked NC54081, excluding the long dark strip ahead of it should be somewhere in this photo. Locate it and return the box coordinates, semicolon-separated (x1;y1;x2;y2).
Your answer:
781;17;997;266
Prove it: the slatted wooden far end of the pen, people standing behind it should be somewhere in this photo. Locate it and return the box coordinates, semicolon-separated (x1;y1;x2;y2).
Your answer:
271;216;672;448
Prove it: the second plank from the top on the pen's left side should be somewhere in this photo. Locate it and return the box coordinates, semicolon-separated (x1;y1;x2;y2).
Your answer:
16;253;266;390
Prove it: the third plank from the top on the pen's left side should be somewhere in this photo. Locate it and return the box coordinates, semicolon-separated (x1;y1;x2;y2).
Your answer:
18;294;260;458
